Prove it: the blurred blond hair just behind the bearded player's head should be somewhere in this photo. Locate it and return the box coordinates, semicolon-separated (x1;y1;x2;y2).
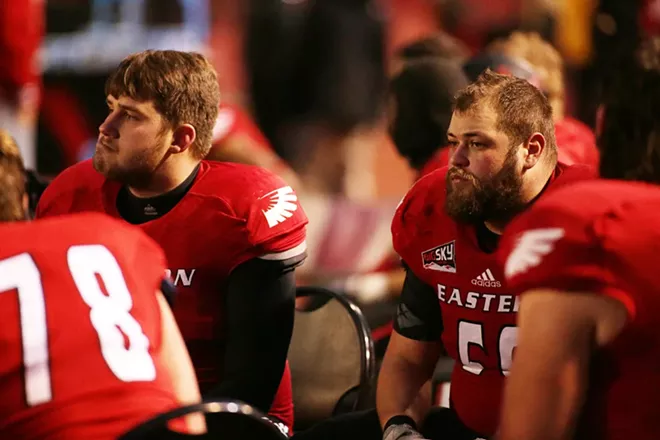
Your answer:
486;32;565;117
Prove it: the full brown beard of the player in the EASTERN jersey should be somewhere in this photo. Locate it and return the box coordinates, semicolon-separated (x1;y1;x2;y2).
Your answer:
445;148;526;224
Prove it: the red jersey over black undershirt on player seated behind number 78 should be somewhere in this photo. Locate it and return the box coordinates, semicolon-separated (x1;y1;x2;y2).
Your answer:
37;161;307;428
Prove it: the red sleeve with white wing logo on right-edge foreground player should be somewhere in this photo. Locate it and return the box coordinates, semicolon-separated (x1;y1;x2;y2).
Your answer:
500;203;635;316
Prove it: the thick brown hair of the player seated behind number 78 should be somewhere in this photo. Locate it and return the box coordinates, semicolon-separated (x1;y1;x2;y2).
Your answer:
105;50;220;159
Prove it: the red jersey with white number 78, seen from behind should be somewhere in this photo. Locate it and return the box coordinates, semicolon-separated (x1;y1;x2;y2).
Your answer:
0;214;178;440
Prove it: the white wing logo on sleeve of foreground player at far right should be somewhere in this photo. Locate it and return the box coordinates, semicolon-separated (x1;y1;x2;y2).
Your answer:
504;228;564;278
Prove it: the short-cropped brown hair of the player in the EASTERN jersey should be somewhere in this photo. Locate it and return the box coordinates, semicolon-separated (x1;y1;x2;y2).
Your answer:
454;69;557;159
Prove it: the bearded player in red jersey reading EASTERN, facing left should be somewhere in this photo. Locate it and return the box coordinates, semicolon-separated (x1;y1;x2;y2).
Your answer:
377;70;591;440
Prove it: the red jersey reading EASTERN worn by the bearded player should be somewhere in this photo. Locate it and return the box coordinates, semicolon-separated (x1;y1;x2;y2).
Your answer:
392;165;588;436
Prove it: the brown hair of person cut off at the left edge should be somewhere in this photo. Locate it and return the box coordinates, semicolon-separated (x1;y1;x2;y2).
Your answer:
0;130;25;222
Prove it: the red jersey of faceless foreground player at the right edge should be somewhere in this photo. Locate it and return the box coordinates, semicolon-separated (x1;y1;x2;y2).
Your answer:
500;180;660;440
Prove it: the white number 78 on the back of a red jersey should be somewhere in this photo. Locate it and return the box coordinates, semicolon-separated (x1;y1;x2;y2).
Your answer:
0;245;156;406
